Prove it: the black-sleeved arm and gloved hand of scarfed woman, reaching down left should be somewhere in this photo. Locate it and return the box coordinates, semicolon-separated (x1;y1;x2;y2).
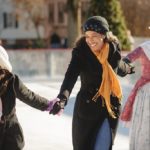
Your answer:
50;49;81;115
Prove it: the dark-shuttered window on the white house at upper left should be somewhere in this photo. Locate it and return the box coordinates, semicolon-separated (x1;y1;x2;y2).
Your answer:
3;12;18;28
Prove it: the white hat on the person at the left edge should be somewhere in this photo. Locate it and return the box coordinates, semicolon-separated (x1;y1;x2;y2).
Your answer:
0;46;12;72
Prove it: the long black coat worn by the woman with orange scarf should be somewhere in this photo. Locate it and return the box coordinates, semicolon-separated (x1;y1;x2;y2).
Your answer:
58;37;129;150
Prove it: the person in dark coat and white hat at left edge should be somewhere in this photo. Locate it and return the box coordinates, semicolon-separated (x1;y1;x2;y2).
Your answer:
0;46;56;150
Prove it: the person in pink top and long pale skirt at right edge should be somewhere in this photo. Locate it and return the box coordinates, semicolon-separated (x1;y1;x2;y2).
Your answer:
120;41;150;150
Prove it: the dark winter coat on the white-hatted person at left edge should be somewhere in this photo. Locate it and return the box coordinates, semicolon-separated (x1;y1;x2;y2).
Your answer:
0;74;49;150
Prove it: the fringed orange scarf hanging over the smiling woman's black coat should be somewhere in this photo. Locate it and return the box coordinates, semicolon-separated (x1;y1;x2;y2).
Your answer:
92;43;122;118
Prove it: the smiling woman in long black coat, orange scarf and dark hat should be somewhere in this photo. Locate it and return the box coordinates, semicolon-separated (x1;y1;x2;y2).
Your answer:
51;16;133;150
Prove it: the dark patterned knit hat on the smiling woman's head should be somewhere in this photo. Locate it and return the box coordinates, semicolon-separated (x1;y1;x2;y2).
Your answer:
83;16;109;35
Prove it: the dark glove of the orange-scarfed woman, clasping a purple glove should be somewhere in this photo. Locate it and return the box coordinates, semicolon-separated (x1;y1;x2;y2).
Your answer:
50;100;66;115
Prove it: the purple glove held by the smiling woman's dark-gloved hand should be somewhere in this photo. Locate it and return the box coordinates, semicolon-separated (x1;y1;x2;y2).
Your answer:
46;98;64;116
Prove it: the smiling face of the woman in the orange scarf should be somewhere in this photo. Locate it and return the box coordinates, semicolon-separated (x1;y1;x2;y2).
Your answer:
85;31;105;51
